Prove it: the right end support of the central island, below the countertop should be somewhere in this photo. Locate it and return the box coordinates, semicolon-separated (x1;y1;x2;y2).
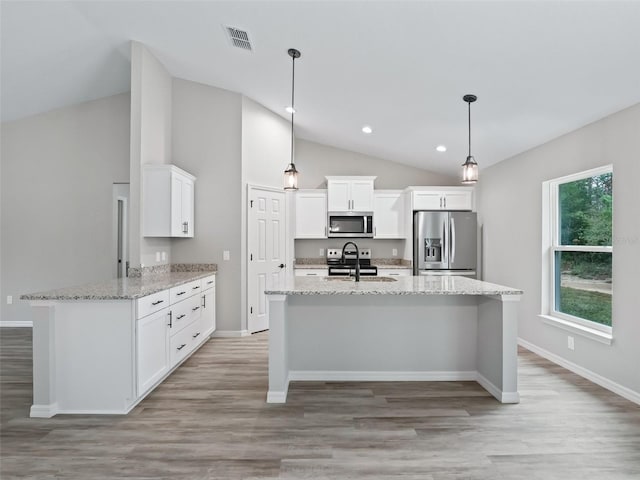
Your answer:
477;295;520;403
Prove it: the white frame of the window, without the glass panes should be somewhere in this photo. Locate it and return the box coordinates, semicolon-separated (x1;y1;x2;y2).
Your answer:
540;164;613;343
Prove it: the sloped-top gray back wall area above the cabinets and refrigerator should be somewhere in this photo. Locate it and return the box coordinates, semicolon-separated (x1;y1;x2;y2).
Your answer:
295;139;460;189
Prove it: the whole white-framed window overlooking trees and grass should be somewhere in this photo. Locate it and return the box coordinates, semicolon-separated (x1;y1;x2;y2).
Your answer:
543;166;613;335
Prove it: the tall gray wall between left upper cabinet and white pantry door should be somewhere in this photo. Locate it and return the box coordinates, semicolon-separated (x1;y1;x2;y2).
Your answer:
171;78;244;331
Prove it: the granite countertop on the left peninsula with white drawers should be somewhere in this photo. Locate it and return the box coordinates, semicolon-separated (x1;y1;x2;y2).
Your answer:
20;264;217;300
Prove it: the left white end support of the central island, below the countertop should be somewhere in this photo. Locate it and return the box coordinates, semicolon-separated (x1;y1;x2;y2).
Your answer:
267;295;289;403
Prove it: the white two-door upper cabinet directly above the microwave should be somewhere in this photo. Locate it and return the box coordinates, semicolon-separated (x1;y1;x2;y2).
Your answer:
326;177;376;212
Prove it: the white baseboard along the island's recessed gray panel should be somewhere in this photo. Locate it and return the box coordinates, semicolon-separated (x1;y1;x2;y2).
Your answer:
289;370;477;382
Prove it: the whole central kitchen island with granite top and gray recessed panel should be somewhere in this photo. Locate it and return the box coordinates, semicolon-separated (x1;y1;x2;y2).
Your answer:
266;276;523;403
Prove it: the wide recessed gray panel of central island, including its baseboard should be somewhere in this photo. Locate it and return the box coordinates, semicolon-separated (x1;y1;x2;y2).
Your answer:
286;295;478;381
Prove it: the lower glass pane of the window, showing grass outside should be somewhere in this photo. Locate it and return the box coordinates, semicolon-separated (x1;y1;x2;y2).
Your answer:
555;252;612;326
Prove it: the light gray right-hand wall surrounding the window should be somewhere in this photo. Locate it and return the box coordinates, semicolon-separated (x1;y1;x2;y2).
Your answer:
477;104;640;399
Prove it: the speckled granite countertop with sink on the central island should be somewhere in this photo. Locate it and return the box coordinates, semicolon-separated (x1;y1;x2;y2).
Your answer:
266;276;523;295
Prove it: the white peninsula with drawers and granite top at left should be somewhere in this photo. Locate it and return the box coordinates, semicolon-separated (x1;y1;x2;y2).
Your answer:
21;264;217;417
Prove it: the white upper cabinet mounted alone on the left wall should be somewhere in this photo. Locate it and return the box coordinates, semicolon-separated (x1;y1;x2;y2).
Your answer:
142;165;196;238
